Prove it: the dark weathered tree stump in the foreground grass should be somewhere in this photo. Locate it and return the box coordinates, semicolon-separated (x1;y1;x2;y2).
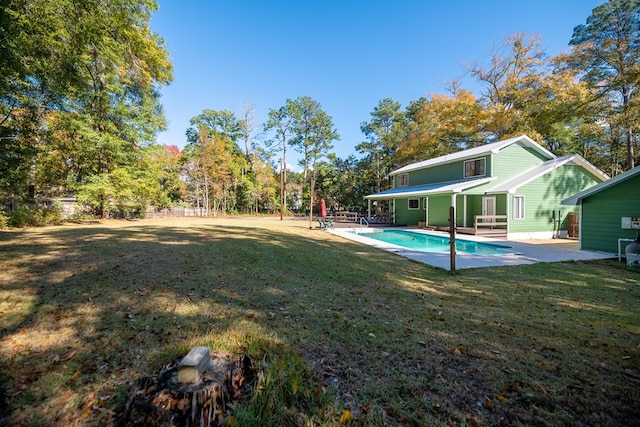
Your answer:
121;355;257;427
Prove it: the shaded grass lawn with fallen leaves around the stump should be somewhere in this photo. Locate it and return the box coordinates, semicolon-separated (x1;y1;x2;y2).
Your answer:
0;218;640;426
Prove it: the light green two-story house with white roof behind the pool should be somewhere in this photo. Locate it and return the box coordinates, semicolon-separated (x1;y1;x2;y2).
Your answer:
365;135;609;239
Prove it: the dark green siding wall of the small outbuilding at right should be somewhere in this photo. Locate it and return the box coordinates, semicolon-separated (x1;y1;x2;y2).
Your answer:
581;175;640;253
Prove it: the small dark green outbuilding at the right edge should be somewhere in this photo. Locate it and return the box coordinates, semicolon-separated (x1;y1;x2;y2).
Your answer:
561;166;640;255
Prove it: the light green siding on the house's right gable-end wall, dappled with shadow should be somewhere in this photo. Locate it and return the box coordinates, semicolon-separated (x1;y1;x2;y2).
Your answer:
509;165;600;233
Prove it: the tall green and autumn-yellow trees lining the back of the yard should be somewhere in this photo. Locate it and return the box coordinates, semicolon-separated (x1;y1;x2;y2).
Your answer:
0;0;640;226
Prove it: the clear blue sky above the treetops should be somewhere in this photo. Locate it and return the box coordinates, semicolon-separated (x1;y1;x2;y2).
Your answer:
151;0;604;164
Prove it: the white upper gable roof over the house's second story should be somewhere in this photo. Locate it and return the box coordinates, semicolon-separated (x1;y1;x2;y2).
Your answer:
389;135;556;176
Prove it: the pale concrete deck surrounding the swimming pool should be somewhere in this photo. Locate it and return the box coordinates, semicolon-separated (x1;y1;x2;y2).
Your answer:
330;228;617;270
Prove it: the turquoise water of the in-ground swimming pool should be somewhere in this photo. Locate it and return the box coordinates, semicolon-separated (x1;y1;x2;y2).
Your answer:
350;229;515;255
